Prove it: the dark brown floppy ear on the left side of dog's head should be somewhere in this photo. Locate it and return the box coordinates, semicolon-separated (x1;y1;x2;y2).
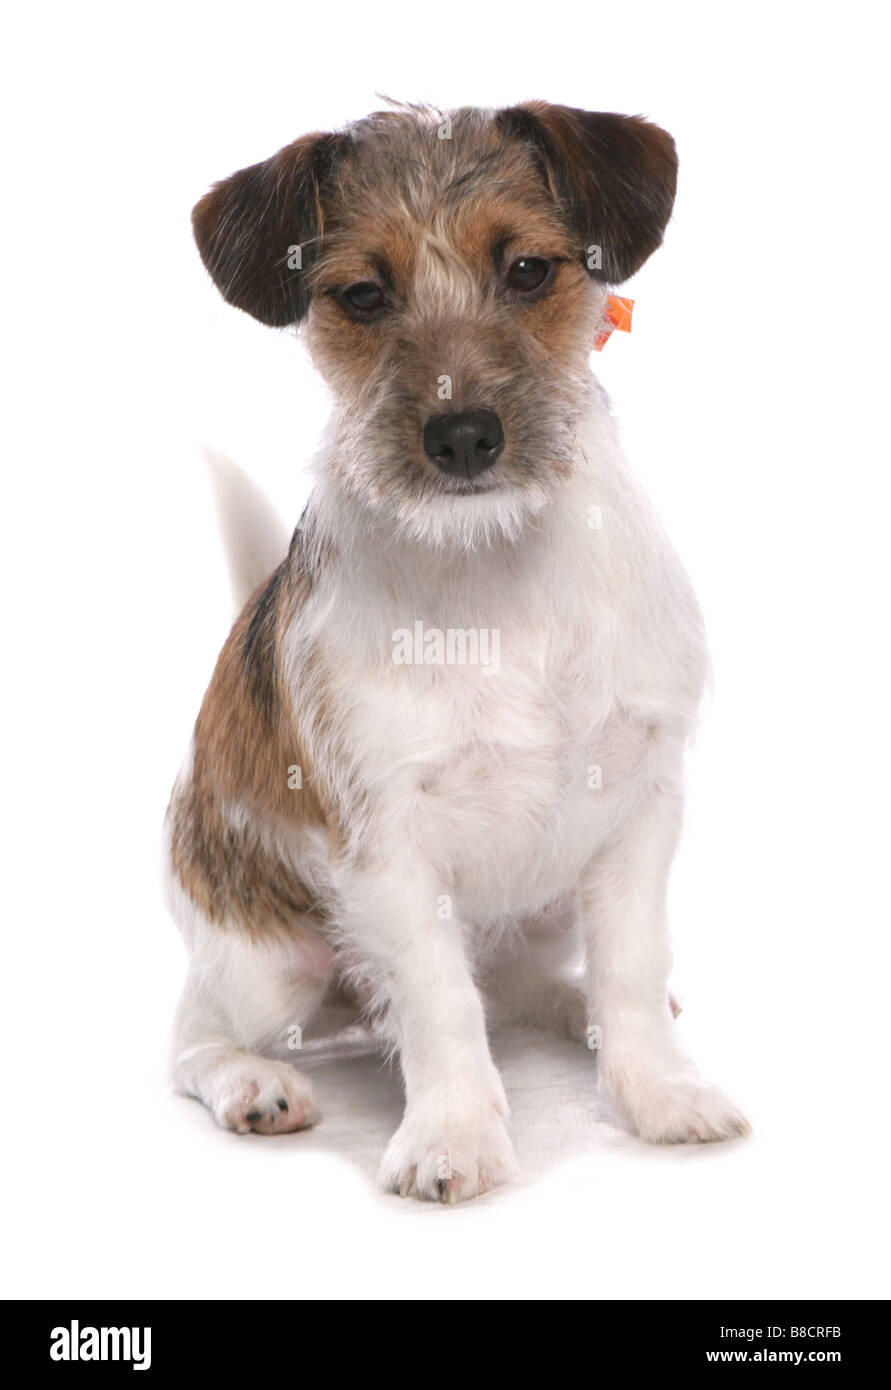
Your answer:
192;135;346;328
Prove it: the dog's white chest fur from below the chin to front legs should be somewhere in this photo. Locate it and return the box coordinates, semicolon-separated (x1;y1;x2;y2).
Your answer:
295;405;705;919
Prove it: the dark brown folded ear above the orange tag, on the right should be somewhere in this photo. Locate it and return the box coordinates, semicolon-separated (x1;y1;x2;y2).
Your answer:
498;101;677;285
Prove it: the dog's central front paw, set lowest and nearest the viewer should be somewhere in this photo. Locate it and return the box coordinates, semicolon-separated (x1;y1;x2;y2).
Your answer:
381;1106;517;1204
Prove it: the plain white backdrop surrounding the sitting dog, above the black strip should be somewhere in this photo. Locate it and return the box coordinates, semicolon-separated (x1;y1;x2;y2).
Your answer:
1;0;890;1298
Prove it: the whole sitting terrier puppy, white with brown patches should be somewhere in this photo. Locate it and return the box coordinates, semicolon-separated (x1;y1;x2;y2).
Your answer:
165;101;748;1202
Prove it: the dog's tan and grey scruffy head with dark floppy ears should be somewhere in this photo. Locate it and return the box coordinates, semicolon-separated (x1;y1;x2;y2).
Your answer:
193;103;677;534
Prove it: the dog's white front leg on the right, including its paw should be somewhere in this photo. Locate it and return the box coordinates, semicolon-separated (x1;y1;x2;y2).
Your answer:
581;788;748;1144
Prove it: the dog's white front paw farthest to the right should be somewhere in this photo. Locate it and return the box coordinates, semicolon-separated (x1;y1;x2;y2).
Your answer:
606;1066;749;1144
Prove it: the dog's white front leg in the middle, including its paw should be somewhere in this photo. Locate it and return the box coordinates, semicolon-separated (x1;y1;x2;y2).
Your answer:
345;870;516;1202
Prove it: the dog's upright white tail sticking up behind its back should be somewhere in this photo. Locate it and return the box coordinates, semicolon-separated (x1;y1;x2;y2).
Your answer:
204;448;289;613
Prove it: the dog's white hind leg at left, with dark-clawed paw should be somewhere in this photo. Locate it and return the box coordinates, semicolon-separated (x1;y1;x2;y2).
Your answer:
171;920;334;1134
